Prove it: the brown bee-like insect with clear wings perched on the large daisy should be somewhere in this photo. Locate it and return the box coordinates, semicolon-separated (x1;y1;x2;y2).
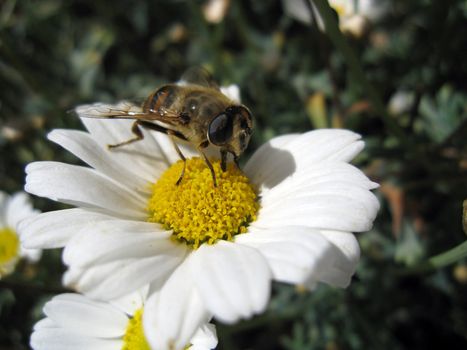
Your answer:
78;68;253;186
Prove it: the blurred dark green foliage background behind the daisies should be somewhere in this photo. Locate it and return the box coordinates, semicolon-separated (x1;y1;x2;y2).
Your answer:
0;0;467;350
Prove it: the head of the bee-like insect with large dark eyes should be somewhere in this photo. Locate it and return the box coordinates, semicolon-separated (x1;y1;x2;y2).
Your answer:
207;106;253;157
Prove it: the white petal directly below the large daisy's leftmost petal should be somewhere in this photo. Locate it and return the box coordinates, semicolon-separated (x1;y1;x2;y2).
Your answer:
63;220;176;267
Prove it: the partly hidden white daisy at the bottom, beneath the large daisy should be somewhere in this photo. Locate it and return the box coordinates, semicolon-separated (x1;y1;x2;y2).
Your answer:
31;292;217;350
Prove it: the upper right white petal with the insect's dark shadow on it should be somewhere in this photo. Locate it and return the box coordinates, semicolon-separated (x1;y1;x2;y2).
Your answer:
245;129;363;188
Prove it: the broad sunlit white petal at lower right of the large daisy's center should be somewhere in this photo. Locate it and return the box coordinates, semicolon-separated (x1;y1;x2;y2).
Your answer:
236;227;337;284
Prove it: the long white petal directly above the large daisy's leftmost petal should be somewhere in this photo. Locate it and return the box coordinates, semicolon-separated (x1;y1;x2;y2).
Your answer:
25;162;146;219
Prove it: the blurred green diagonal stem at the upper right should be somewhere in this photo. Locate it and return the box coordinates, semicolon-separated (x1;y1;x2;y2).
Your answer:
312;0;408;143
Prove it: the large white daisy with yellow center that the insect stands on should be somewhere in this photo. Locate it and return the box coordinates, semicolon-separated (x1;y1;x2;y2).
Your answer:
20;97;379;349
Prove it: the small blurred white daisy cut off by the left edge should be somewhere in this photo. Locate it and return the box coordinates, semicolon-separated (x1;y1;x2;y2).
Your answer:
0;191;41;278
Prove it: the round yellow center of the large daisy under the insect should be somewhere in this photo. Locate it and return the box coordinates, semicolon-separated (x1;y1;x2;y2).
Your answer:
148;158;259;249
